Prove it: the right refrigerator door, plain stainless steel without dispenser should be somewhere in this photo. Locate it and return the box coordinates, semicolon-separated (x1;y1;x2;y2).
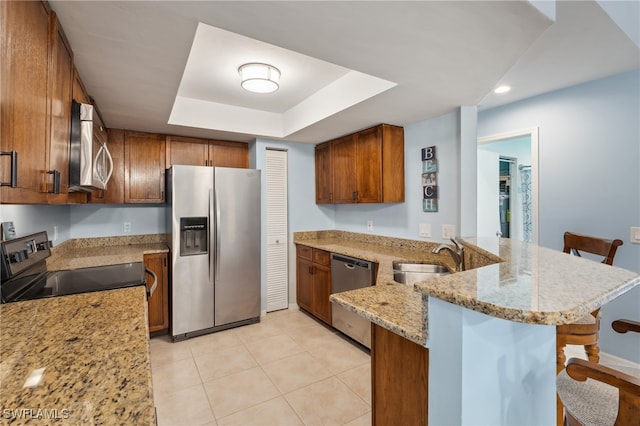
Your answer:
212;168;260;326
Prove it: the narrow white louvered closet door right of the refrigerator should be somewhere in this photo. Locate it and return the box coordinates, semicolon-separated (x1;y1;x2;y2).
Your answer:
266;149;289;312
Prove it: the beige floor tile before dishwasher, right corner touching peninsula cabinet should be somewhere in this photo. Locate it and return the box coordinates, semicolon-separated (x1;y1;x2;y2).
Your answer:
305;337;371;374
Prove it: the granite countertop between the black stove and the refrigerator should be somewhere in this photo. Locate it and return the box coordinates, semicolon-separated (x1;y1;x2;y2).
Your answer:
47;234;169;271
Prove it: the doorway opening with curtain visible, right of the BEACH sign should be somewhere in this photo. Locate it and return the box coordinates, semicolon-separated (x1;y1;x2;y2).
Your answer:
477;128;538;243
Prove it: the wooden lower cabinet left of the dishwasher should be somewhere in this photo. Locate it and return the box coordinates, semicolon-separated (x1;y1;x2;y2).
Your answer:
296;245;331;325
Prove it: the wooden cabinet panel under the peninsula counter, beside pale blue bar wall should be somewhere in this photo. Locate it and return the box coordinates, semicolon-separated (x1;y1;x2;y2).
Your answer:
371;324;429;426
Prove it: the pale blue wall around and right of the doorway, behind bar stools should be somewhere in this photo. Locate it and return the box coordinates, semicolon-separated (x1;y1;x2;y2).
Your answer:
478;70;640;362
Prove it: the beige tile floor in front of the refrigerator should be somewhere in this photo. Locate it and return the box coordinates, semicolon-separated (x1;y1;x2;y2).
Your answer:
151;310;371;426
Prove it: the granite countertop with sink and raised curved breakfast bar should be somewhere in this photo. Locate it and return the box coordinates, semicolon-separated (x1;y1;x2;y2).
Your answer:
294;231;640;345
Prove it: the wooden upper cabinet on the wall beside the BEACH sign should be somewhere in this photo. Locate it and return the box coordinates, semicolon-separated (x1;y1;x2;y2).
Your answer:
316;124;404;204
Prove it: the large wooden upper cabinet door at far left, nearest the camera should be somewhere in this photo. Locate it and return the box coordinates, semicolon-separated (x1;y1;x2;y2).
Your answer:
0;1;50;204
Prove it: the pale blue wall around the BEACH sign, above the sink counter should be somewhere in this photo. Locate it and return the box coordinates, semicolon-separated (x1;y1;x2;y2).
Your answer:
335;111;460;241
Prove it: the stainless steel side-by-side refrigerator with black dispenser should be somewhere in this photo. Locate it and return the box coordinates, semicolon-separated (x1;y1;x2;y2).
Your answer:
167;166;260;341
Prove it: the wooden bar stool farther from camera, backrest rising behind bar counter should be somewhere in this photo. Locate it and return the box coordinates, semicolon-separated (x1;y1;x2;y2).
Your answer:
556;232;622;425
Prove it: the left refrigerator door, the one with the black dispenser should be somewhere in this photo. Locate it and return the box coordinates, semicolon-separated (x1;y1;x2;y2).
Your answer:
169;166;214;336
